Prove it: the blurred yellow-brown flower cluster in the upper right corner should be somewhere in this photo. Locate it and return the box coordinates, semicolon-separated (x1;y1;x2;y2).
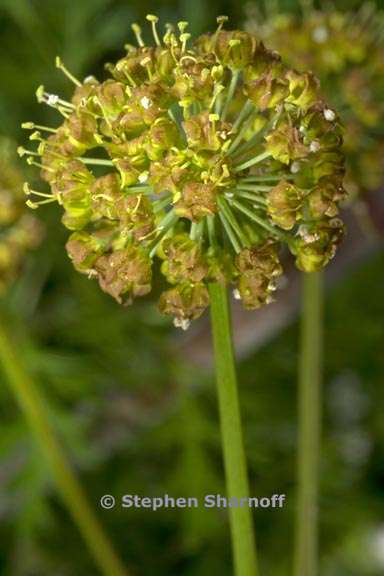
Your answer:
247;2;384;195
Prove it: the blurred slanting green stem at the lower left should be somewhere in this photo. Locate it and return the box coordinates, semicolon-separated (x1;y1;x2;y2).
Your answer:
0;324;127;576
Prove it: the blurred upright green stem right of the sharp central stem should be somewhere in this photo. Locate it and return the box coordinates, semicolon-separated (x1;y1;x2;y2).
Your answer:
295;272;323;576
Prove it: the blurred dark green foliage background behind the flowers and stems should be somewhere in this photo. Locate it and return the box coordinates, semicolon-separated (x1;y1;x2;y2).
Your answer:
0;0;384;576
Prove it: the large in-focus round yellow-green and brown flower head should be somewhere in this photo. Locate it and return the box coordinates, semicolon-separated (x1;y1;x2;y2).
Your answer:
20;15;344;328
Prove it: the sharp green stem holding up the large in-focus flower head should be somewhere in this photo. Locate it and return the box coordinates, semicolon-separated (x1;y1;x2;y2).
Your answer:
209;283;258;576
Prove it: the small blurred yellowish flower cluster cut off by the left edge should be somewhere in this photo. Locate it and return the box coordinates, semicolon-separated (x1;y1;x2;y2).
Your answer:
0;138;41;295
